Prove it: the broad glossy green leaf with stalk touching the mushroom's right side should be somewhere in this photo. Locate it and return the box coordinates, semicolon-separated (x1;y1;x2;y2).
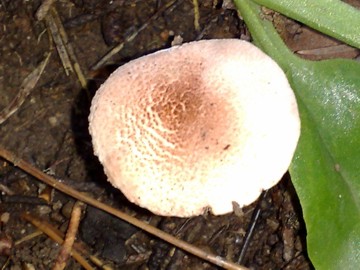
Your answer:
235;0;360;269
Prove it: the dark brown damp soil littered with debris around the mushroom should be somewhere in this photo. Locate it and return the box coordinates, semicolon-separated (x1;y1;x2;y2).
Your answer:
0;0;358;270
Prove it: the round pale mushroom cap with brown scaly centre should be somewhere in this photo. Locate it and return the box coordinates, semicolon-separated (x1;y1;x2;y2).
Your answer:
89;39;300;217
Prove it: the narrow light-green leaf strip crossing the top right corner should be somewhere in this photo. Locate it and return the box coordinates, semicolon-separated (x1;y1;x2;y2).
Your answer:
254;0;360;48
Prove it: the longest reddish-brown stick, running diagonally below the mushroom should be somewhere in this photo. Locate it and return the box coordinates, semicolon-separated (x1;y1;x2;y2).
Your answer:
0;147;248;270
